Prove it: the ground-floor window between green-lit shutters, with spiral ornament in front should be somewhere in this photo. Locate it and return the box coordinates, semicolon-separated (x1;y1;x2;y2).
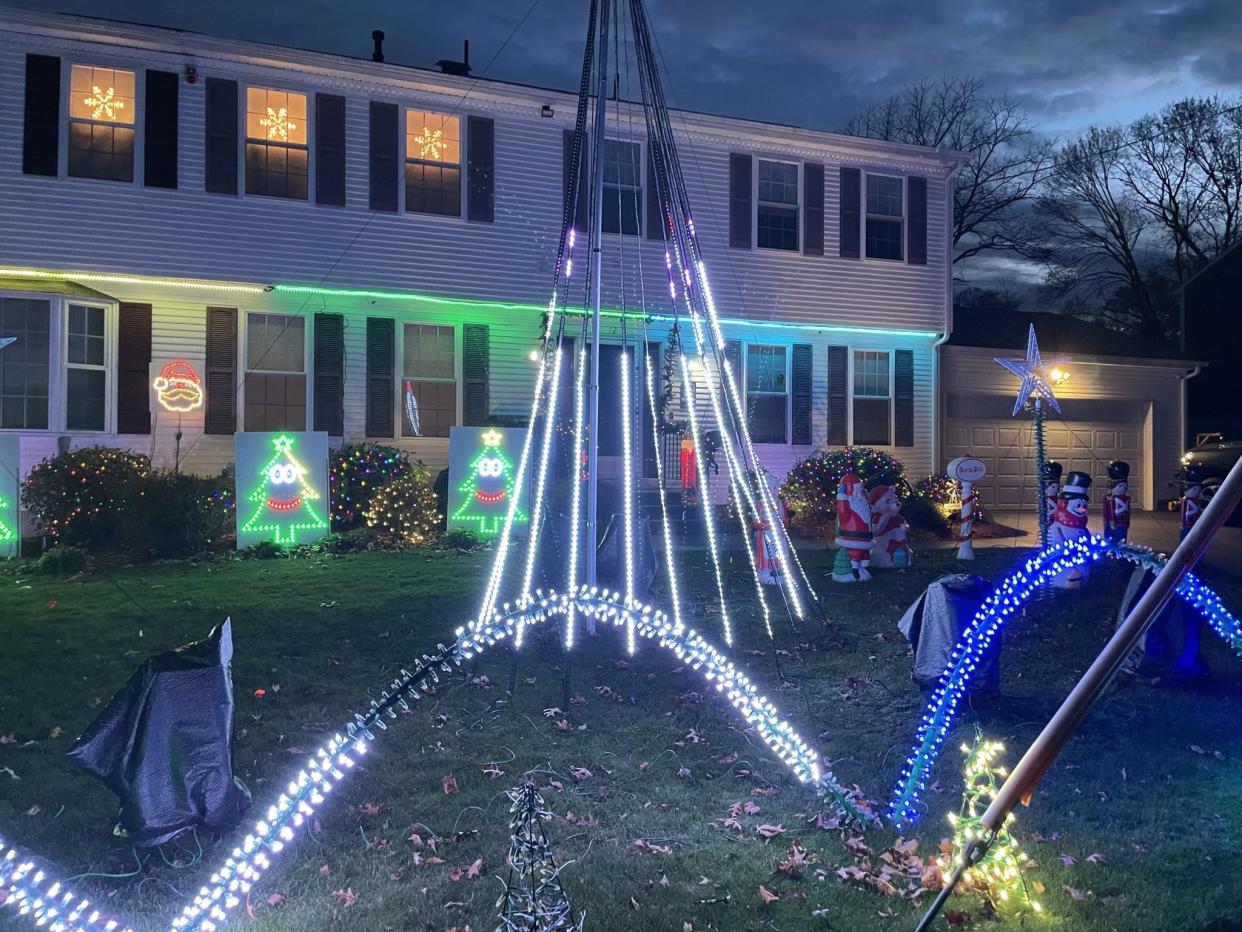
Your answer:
401;323;457;437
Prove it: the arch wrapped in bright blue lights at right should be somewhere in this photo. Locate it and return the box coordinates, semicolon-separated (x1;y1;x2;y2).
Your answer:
886;536;1242;825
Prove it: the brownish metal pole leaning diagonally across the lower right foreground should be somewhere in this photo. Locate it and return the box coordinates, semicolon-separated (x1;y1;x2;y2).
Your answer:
915;459;1242;932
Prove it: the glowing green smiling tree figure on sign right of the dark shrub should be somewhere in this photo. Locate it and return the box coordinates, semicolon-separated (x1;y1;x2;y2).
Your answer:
237;434;328;547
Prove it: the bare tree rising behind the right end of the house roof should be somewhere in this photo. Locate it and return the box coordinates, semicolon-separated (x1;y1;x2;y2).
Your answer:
845;76;1053;262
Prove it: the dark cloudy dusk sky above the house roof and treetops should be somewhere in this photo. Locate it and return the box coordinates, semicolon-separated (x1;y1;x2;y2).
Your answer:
19;0;1242;138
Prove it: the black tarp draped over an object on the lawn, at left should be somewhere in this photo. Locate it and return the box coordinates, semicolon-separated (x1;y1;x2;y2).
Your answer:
68;620;250;847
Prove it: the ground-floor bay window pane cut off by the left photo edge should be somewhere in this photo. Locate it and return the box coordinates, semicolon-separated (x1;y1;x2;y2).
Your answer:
0;298;52;430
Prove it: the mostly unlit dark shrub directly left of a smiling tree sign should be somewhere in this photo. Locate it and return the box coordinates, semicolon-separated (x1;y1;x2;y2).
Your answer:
125;472;233;558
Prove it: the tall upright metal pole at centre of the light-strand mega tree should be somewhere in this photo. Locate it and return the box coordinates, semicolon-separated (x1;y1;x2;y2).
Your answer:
584;0;612;591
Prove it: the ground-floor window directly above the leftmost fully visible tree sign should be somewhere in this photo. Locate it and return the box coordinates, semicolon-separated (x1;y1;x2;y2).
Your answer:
245;313;307;430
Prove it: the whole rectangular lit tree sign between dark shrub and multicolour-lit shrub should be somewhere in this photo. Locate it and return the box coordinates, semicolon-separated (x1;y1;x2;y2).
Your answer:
235;430;328;549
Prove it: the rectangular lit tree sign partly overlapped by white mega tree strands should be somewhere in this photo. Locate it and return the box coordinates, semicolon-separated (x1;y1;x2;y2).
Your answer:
448;427;529;537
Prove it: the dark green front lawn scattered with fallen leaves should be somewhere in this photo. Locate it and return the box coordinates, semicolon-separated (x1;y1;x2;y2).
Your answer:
0;548;1242;932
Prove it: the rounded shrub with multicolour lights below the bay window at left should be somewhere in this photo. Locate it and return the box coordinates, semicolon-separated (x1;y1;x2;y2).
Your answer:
21;446;150;547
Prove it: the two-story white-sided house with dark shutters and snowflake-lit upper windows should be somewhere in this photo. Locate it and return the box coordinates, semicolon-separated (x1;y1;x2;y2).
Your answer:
0;10;960;504
